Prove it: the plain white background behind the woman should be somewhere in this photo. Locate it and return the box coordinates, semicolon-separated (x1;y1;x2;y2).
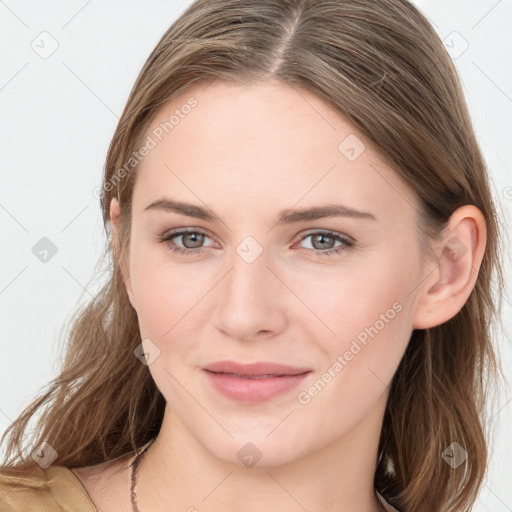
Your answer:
0;0;512;512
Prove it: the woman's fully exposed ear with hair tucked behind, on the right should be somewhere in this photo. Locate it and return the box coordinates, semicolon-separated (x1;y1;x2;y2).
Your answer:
413;205;487;329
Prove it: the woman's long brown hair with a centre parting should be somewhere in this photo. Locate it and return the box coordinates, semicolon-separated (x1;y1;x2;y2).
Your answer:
2;0;503;512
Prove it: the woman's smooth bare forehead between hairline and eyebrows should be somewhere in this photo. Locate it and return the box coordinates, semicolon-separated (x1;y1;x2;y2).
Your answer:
134;81;417;224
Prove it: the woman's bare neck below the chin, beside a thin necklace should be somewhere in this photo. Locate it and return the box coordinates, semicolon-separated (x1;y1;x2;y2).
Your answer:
137;400;384;512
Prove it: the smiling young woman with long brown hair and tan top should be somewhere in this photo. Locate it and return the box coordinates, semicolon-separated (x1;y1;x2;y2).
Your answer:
0;0;503;512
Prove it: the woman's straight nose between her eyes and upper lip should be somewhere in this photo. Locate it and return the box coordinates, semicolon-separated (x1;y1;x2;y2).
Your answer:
214;242;292;341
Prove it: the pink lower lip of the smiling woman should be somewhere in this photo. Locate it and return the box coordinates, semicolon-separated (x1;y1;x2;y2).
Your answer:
204;370;310;404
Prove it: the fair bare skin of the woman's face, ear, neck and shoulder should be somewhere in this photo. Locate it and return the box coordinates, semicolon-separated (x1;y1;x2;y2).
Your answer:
75;81;486;512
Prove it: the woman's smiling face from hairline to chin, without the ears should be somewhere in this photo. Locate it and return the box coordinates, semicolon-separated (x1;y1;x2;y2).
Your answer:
119;82;426;465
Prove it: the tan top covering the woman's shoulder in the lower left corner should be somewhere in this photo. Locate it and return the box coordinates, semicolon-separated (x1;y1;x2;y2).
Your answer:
0;466;97;512
